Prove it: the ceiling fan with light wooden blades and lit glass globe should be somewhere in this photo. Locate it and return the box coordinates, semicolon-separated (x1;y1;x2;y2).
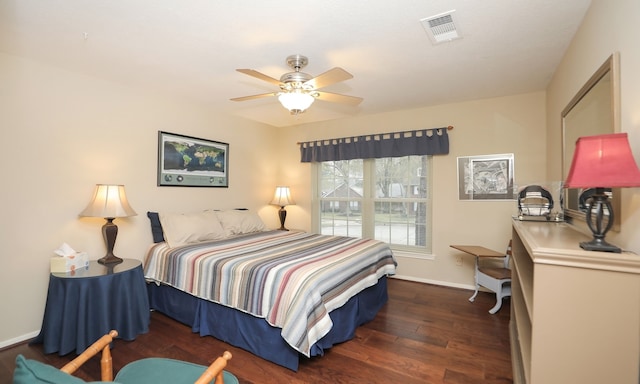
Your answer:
231;55;362;115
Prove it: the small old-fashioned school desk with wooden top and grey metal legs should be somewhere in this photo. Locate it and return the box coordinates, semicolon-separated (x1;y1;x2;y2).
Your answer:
451;241;511;315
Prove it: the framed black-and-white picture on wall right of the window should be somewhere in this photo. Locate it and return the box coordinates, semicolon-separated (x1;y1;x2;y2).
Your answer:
458;153;517;201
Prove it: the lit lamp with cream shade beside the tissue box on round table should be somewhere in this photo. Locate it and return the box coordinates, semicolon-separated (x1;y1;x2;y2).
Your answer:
80;184;137;264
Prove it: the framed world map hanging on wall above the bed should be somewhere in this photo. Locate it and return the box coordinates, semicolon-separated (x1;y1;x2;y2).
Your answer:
158;131;229;188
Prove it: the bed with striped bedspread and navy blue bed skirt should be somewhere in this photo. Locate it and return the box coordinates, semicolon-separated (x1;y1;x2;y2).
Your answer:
144;213;396;371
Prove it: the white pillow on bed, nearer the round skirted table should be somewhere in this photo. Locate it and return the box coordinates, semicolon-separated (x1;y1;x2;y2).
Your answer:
158;211;226;248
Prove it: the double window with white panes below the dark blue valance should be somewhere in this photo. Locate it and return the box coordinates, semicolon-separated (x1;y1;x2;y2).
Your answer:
314;155;431;251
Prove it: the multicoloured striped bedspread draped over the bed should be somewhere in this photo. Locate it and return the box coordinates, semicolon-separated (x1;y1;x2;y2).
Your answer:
144;231;396;357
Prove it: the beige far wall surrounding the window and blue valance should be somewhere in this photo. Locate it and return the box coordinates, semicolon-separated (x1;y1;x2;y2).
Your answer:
280;92;546;287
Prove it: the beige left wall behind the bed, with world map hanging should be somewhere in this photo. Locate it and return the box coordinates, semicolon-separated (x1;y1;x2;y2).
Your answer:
0;54;278;346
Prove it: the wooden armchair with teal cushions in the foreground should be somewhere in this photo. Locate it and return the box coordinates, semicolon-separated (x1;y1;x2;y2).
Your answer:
14;330;238;384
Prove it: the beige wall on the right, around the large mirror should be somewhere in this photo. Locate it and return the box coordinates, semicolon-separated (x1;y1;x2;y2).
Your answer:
546;0;640;253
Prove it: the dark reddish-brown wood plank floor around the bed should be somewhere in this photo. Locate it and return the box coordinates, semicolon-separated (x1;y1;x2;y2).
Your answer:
0;279;512;384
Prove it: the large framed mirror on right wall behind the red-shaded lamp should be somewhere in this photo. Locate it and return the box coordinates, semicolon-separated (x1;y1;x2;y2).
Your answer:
562;53;620;231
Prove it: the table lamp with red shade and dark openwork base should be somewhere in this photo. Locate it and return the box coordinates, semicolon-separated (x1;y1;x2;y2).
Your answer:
564;133;640;253
